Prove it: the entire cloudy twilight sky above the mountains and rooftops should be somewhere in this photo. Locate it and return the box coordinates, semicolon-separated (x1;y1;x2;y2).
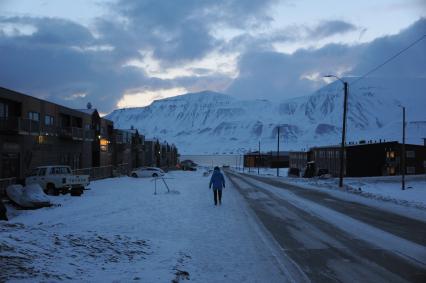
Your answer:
0;0;426;113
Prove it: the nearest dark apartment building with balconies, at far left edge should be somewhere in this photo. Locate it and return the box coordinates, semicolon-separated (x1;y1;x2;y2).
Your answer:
0;88;95;182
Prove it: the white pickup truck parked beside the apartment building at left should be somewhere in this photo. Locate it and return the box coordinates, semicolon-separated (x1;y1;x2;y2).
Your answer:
25;165;90;196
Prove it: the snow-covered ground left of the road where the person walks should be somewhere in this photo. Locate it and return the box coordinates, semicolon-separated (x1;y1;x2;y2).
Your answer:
0;170;286;282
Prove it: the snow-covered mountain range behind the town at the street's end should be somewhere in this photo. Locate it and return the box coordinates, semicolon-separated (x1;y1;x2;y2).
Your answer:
107;78;426;154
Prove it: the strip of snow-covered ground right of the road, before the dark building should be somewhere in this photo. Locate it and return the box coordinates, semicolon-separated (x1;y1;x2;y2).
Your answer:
239;168;426;209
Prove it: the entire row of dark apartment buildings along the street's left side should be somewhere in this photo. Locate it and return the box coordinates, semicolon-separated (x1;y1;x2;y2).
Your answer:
0;87;178;184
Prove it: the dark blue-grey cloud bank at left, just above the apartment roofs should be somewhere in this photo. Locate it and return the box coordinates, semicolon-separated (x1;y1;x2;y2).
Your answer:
0;15;163;111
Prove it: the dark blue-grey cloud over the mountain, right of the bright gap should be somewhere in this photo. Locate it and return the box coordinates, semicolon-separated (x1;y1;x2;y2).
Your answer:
227;44;362;100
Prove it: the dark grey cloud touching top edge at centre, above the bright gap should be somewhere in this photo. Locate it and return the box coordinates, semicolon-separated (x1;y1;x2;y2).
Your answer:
103;0;277;66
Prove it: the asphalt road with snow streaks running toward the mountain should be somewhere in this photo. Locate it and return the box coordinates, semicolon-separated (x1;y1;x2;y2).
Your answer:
226;172;426;282
